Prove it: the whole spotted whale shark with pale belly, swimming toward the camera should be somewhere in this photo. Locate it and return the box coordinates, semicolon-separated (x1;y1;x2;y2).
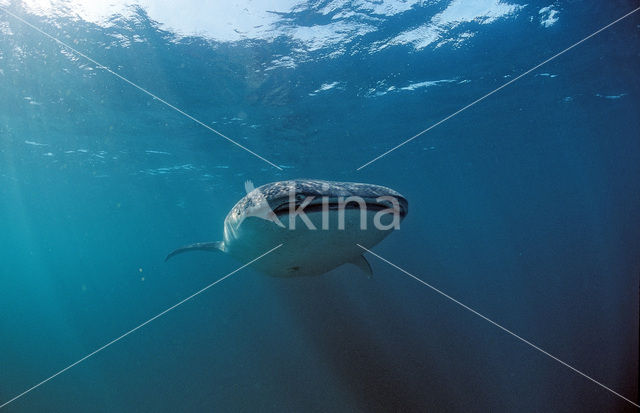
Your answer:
165;179;409;277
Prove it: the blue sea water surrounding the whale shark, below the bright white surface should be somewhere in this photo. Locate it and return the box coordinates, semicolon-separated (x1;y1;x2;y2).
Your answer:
0;0;640;412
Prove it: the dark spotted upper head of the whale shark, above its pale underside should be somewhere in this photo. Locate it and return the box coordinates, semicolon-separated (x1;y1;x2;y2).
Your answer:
225;179;409;239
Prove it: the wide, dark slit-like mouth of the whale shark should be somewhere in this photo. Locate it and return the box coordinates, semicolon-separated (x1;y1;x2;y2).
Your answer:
273;197;408;218
